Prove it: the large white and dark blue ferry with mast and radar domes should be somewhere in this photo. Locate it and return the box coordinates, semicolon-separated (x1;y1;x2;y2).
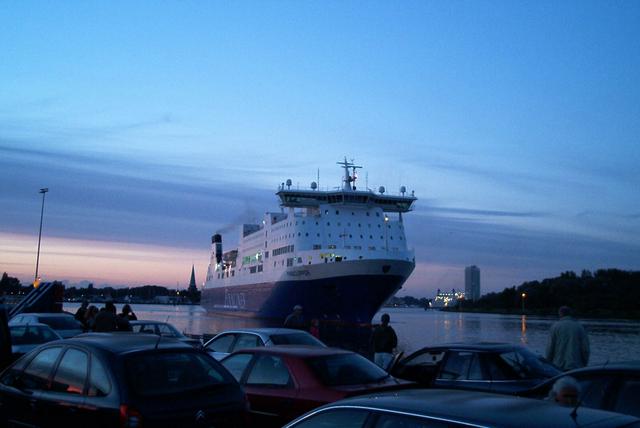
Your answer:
201;158;416;325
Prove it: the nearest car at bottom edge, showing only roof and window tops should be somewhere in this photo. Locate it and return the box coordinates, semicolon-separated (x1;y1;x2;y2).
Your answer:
285;389;640;428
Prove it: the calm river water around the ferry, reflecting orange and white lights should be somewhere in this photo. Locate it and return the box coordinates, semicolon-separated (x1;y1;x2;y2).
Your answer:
64;303;640;364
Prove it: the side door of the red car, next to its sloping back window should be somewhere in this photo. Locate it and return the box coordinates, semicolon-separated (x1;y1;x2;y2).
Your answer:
241;354;299;426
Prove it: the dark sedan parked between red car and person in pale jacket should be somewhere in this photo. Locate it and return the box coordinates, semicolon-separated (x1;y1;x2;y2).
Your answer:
389;343;561;393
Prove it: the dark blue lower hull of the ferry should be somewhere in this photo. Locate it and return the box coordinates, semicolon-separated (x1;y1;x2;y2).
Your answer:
201;272;413;325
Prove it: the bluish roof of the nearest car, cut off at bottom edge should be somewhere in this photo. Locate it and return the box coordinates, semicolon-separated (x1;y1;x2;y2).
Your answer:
302;389;639;427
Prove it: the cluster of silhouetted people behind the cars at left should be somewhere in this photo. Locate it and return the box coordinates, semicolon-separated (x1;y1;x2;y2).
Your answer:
74;300;138;332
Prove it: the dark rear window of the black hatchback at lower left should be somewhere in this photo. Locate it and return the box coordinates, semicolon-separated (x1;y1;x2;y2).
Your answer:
125;350;234;396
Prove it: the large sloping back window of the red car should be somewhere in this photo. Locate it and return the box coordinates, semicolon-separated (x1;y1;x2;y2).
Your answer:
306;354;388;386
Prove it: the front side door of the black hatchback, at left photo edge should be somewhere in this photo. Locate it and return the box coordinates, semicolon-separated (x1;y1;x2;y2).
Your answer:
0;346;62;426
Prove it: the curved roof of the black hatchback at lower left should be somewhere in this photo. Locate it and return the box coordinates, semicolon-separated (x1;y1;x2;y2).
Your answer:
51;332;195;354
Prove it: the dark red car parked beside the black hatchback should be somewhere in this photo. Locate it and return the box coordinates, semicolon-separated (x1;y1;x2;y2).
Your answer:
221;345;415;427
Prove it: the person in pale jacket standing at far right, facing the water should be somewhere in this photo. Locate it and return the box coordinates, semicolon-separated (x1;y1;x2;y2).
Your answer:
546;306;590;371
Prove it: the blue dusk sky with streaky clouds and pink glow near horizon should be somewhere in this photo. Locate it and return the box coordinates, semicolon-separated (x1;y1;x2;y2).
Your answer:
0;0;640;297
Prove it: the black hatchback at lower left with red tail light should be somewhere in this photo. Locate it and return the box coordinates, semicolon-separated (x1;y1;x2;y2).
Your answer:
0;333;248;428
